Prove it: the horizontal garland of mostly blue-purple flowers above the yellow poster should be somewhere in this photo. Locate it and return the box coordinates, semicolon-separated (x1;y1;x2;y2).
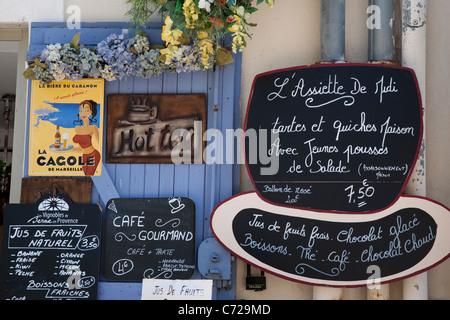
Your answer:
24;30;215;84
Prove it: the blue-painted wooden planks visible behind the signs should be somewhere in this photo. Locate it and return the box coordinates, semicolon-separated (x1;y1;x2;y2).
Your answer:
24;23;241;300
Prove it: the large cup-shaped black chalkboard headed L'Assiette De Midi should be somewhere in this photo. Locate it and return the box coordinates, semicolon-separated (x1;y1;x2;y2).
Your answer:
245;64;422;212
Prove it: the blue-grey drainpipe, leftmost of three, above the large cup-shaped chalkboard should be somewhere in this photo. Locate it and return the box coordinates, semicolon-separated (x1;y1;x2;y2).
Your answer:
313;0;345;300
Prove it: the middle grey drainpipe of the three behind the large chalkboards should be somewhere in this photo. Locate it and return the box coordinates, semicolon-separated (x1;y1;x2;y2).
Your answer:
367;0;395;300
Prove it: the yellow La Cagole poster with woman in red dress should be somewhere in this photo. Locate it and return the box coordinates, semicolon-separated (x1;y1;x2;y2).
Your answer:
29;79;104;176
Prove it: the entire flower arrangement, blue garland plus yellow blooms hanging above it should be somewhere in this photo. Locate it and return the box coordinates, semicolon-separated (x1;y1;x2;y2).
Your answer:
24;0;274;84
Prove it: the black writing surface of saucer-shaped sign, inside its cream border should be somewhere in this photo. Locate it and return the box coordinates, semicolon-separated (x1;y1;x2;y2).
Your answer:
233;208;437;282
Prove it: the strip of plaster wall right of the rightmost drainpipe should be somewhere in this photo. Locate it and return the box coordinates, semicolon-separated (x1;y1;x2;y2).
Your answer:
426;0;450;299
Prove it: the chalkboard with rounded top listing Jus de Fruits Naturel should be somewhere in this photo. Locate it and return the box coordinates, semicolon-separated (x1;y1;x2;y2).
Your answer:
0;194;102;300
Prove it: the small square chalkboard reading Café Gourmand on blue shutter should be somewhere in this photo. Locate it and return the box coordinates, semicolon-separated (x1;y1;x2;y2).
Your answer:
102;197;195;282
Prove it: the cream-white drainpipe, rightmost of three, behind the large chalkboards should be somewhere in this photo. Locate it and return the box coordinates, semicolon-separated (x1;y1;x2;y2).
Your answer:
402;0;428;300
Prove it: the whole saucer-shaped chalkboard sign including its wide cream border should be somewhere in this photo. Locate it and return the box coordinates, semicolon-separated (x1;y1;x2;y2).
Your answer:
211;192;450;287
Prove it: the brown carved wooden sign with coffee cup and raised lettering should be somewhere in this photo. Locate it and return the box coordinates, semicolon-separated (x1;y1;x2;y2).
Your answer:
106;94;206;164
